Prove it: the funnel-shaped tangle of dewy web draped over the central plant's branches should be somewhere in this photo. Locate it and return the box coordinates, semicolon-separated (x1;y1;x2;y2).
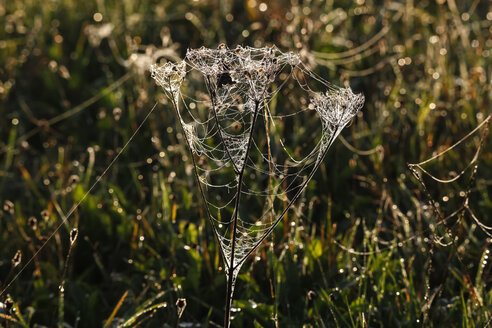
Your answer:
151;45;364;278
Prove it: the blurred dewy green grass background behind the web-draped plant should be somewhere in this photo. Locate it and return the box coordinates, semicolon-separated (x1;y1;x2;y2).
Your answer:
0;0;492;327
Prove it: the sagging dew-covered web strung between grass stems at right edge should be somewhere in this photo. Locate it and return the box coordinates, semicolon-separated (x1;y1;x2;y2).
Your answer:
333;115;492;256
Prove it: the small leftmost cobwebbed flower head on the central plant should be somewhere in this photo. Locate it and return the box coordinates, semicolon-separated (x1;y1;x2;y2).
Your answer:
150;61;186;95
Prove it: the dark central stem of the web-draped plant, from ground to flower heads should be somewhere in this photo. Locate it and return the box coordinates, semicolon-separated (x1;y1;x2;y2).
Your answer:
224;101;259;328
